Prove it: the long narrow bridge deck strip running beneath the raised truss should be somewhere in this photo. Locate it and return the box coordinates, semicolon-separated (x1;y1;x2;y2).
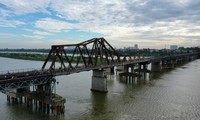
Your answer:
0;54;197;85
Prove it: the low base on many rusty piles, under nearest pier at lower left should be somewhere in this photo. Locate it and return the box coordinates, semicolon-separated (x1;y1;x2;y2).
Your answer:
7;91;66;115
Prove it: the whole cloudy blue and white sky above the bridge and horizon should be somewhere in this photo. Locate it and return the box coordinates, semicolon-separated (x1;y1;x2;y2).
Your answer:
0;0;200;48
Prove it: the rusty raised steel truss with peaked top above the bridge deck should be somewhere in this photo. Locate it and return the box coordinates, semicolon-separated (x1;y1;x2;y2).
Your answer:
42;38;120;70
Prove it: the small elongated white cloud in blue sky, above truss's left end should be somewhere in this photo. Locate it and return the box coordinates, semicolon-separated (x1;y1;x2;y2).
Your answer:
35;18;74;32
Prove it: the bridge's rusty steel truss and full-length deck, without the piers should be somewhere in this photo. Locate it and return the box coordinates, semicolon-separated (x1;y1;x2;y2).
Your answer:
0;38;199;92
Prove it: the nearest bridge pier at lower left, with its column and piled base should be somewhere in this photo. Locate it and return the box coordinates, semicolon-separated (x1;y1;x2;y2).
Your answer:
5;78;66;115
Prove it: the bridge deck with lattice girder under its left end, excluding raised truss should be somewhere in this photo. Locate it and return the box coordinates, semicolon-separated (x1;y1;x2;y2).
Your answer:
0;53;199;92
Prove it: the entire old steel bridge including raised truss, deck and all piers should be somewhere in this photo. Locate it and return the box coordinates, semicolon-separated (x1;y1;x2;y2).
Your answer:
0;38;200;114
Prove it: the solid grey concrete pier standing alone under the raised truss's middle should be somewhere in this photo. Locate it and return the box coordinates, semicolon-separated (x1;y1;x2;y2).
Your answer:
91;70;108;92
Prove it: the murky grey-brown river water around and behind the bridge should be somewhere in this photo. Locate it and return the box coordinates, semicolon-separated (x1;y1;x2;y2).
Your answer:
0;58;200;120
